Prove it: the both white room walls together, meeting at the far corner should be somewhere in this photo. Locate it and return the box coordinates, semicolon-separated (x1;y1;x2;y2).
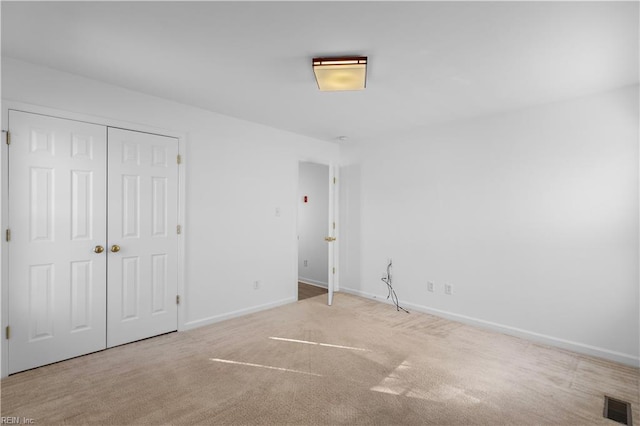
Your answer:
2;58;640;370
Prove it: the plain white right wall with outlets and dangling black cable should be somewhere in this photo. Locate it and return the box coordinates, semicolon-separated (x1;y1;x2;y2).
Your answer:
341;86;639;365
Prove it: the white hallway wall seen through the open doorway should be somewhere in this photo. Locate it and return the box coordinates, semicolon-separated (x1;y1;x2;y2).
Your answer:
298;162;329;287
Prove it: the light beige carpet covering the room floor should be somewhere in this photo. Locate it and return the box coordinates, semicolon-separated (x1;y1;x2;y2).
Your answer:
1;294;640;426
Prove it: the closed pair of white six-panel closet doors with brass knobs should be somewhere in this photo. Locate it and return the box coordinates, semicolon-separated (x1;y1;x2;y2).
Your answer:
7;111;178;373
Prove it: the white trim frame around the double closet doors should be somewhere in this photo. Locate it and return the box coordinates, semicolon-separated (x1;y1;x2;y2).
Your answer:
0;99;188;377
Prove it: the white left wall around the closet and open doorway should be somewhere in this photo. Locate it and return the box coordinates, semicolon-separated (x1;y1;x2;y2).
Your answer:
2;58;339;328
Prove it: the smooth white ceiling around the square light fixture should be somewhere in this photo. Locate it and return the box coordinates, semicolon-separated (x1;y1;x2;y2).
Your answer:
1;1;638;141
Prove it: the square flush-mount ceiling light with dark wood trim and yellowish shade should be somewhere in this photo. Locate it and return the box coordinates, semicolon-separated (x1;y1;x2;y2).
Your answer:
313;56;367;91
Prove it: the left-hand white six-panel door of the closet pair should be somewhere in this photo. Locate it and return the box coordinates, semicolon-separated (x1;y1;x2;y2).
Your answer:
8;111;107;373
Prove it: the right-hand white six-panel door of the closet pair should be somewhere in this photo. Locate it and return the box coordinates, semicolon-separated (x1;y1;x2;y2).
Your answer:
107;128;178;347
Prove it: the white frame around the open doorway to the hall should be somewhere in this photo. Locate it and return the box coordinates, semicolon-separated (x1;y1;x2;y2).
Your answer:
293;158;340;305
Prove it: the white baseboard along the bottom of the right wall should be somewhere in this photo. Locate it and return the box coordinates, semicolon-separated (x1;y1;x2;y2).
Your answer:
342;288;640;368
